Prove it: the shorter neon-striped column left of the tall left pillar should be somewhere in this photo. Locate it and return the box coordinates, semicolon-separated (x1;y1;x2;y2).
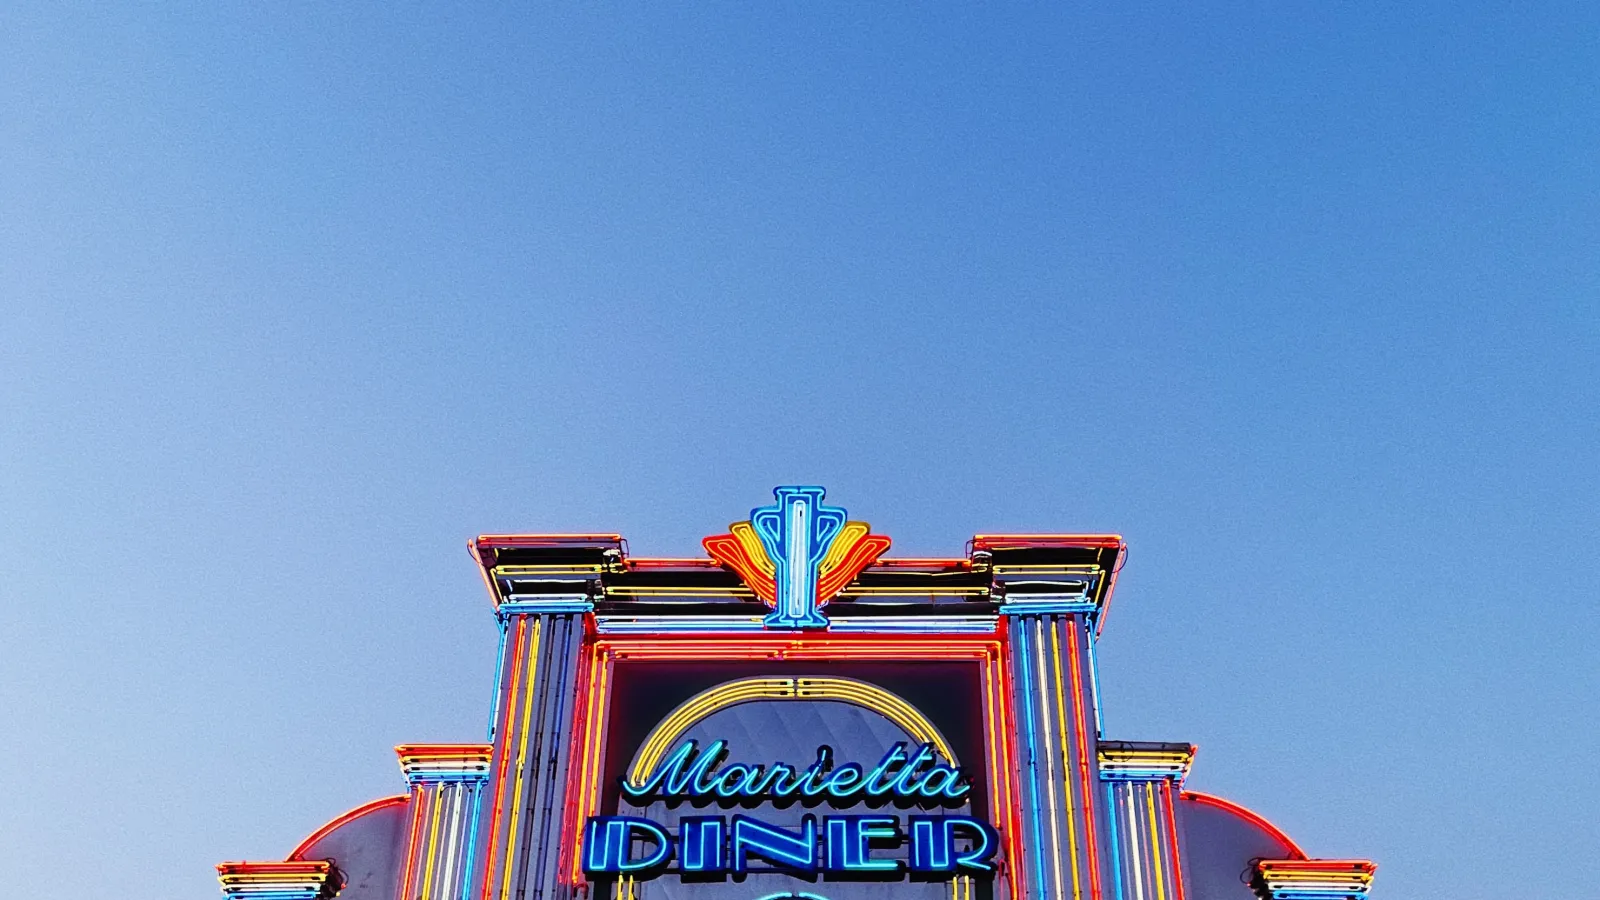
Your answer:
395;743;490;900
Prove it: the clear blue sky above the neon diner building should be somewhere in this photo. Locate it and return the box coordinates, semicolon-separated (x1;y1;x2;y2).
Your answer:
0;2;1600;900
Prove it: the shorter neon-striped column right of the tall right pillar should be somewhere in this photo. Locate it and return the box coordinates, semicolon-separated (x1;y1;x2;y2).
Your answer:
1098;741;1195;900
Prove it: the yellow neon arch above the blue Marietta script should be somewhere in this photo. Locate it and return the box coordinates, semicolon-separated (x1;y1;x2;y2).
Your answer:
627;676;957;785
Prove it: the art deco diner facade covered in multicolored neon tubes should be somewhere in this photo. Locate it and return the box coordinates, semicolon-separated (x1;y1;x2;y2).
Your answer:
218;487;1374;900
